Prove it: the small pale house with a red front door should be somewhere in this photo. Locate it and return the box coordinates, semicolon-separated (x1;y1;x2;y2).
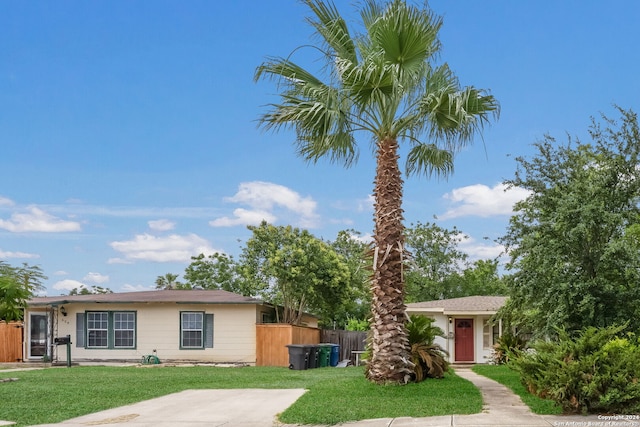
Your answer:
407;296;507;363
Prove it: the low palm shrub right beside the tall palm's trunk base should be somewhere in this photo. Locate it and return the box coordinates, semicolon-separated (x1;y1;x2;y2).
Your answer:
407;315;449;382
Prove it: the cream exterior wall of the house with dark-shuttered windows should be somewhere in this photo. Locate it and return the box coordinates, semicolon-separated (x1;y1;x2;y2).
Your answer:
37;303;260;364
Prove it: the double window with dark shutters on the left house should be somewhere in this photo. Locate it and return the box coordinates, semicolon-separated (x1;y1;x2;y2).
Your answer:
84;311;136;348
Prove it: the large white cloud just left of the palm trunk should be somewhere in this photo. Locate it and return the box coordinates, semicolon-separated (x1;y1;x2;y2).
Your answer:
209;181;318;228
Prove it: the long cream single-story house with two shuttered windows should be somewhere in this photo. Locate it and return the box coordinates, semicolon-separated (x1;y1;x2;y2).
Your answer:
24;290;317;364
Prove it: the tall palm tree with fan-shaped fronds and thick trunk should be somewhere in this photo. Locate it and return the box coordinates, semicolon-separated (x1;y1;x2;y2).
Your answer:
255;0;499;383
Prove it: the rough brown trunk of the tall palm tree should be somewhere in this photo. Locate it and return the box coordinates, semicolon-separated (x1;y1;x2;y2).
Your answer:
366;138;413;383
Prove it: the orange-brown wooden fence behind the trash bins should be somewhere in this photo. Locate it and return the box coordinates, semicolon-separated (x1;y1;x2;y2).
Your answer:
256;323;320;367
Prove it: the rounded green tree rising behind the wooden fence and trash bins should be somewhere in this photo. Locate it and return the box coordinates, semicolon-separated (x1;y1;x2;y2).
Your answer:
241;222;351;326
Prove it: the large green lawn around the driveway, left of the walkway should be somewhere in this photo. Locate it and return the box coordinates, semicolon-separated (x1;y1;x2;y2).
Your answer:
0;367;482;427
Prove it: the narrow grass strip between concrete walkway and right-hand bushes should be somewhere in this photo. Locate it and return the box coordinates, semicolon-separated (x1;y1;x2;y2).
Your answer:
472;365;562;415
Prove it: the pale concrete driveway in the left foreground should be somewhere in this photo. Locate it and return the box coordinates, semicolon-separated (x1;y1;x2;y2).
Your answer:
28;389;305;427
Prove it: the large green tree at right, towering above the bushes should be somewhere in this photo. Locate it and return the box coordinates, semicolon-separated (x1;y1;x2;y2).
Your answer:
502;108;640;335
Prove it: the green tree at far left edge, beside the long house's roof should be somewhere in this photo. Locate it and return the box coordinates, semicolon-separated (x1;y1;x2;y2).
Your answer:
0;261;47;321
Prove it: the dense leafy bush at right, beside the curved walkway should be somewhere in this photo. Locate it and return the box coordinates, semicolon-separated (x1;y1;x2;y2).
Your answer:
510;325;640;414
